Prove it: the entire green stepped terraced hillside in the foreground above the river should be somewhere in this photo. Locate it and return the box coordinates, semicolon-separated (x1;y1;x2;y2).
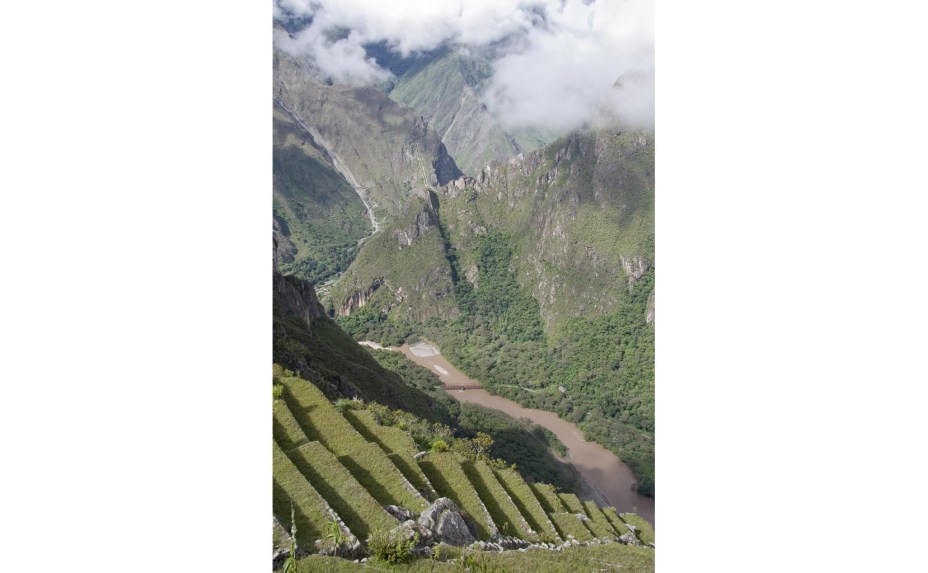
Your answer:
273;370;654;571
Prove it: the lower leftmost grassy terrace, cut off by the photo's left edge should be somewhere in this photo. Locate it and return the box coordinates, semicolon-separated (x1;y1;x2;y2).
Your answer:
273;442;342;550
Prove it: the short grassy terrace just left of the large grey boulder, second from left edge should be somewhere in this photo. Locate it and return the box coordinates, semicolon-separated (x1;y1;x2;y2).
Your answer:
289;442;396;540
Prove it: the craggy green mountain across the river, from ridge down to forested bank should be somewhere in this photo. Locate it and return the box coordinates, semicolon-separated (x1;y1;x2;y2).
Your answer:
330;129;655;495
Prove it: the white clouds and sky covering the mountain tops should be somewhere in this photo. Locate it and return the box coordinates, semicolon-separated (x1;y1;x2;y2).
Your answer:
274;0;654;131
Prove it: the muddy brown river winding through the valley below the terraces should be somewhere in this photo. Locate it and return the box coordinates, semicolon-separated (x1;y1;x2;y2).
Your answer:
378;342;654;524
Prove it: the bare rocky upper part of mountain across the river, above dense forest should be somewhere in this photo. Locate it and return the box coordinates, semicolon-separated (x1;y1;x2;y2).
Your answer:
331;126;654;334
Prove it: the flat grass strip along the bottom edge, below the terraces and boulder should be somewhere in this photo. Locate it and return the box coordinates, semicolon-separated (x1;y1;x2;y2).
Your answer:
298;543;654;573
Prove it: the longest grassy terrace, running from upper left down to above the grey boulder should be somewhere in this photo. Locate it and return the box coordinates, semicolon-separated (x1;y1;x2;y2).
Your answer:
280;378;428;511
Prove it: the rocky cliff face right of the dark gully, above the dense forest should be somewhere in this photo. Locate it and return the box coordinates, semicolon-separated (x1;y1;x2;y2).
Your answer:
439;129;654;331
